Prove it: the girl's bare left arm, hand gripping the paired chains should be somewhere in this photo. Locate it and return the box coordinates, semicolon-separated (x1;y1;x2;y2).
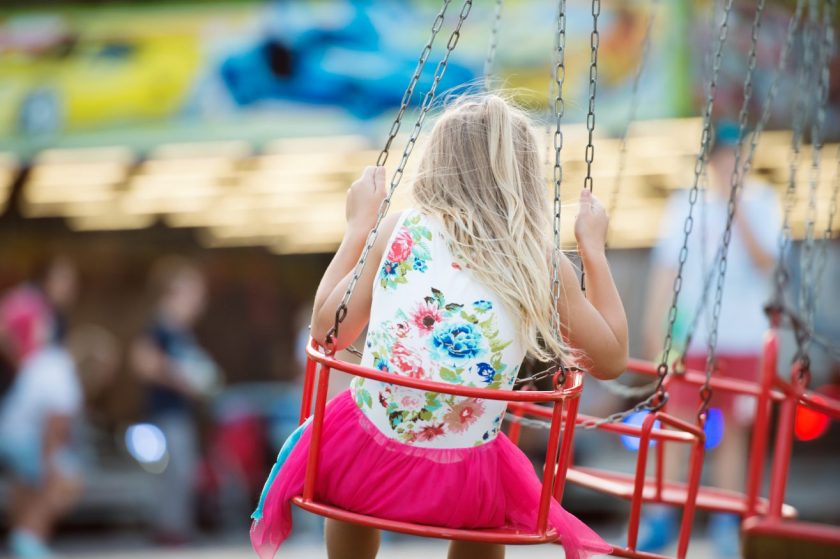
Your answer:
311;167;399;350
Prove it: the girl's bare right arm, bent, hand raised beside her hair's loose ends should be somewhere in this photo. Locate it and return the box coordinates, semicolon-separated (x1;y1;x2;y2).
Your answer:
558;190;628;379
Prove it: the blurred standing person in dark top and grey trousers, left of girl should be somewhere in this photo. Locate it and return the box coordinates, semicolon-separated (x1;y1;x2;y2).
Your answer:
131;257;220;545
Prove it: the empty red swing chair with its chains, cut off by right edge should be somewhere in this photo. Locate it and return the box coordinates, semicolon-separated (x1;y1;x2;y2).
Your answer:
742;0;840;559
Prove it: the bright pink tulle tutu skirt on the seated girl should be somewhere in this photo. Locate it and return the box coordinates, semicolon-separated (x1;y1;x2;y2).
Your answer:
251;390;611;559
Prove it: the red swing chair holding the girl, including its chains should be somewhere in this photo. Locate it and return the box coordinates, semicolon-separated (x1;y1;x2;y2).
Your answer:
292;0;583;544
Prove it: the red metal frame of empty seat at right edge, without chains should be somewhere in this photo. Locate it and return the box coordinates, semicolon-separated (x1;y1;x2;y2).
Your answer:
742;324;840;551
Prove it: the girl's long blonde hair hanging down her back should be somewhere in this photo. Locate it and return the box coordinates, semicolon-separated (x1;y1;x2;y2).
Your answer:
413;94;573;362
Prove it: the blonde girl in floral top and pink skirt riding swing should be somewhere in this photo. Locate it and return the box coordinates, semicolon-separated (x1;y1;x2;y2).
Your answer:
251;95;627;559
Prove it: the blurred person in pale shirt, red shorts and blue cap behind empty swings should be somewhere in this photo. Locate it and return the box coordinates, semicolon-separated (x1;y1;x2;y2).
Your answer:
639;121;781;557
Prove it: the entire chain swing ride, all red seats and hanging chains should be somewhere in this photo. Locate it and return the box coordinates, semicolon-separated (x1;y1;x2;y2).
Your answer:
293;0;840;559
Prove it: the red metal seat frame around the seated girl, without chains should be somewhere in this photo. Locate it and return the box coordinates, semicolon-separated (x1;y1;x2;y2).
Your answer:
292;340;583;545
